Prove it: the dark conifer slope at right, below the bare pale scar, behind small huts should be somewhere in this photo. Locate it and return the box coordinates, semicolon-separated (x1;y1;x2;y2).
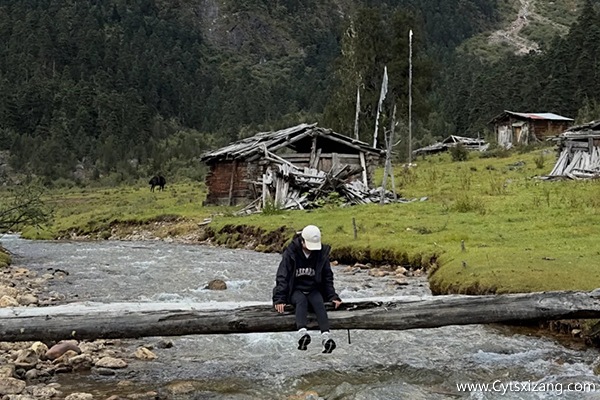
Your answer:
436;0;600;136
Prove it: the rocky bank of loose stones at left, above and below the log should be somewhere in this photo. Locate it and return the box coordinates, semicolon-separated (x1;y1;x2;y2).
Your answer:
0;265;168;400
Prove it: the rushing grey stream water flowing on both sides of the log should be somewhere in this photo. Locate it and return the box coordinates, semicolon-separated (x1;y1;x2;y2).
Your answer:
2;236;600;400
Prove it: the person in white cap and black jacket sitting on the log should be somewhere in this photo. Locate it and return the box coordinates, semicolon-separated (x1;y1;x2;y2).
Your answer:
273;225;342;353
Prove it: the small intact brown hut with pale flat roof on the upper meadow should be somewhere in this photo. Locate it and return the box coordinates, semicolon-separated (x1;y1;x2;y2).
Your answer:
490;111;573;148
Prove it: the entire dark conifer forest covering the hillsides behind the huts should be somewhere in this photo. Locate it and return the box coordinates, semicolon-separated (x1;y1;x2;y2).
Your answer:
0;0;600;183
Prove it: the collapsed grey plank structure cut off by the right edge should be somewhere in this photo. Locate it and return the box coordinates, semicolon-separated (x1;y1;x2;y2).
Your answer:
548;121;600;179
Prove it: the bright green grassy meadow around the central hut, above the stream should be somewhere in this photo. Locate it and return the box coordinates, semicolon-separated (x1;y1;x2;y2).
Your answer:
12;149;600;293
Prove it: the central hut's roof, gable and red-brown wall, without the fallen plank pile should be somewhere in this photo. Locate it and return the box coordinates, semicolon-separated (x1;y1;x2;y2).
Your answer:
202;124;382;205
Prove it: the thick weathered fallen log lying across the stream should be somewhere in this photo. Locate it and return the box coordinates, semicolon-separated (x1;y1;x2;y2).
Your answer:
0;289;600;342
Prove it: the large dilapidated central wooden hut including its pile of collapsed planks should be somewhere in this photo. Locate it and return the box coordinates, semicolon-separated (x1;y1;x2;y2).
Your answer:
202;124;408;213
